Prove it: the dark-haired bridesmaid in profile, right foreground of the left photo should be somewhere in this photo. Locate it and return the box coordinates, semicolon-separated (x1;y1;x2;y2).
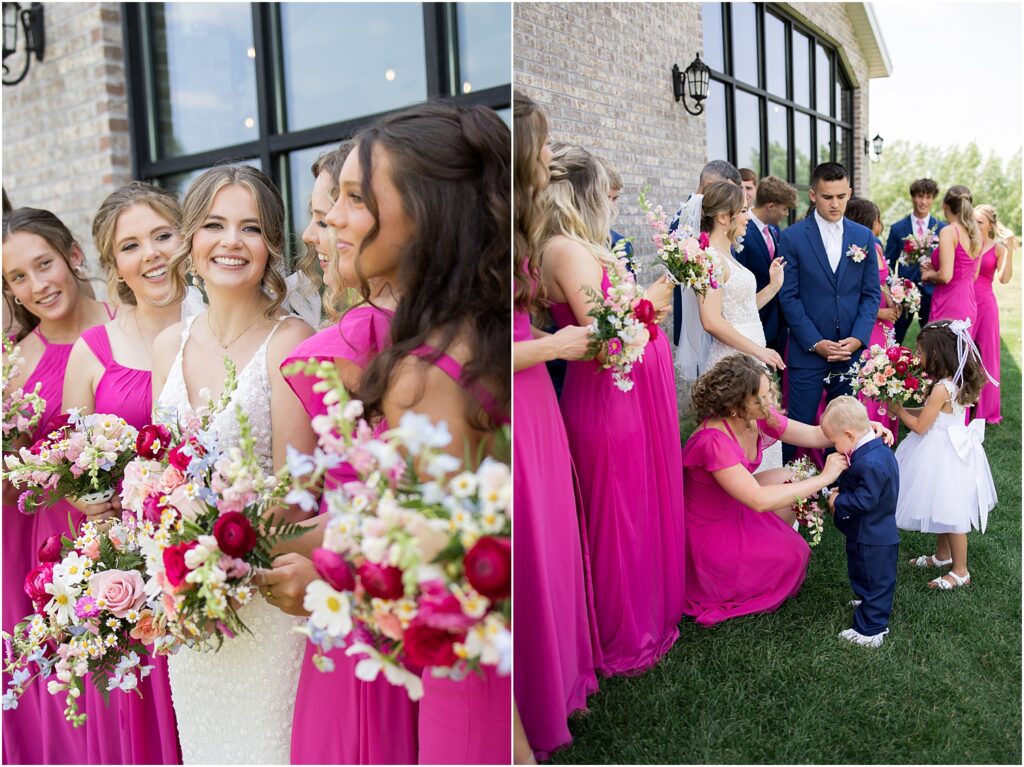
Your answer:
326;102;512;764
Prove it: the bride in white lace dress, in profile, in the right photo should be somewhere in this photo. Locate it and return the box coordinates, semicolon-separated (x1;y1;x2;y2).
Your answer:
677;181;785;471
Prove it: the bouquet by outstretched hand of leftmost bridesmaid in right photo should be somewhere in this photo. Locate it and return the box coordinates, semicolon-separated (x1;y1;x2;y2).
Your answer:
584;246;657;391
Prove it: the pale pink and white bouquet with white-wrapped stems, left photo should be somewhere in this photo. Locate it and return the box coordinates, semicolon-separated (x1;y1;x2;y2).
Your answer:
4;408;137;513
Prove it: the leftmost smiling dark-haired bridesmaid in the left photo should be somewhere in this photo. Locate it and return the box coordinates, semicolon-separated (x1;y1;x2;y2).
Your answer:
3;208;116;764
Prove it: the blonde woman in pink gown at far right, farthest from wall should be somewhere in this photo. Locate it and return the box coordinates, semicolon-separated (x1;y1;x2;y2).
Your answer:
973;205;1014;424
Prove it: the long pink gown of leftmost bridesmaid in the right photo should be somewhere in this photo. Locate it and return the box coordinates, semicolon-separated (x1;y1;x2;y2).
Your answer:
512;296;597;759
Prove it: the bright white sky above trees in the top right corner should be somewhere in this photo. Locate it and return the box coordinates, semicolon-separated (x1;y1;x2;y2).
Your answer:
868;0;1024;158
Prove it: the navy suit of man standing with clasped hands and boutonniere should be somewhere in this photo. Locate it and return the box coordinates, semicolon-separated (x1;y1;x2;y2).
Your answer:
775;213;882;461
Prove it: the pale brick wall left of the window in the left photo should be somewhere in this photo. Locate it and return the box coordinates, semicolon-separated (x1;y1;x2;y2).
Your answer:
2;3;131;292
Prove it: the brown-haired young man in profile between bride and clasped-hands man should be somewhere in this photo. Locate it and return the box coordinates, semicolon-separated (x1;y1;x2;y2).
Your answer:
735;176;797;355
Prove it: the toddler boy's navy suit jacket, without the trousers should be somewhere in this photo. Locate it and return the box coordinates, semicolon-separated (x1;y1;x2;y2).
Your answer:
835;437;899;546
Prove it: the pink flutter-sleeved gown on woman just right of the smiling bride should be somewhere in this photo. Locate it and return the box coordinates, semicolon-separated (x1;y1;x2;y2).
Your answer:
282;306;417;764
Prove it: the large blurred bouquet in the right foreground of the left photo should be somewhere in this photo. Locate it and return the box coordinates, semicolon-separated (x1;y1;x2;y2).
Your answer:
284;364;512;700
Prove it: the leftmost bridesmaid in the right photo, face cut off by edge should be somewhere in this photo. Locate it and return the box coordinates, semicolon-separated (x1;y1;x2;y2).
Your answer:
512;93;597;762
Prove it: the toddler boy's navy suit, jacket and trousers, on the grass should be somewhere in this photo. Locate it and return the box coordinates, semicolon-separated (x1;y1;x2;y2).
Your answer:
835;437;899;637
